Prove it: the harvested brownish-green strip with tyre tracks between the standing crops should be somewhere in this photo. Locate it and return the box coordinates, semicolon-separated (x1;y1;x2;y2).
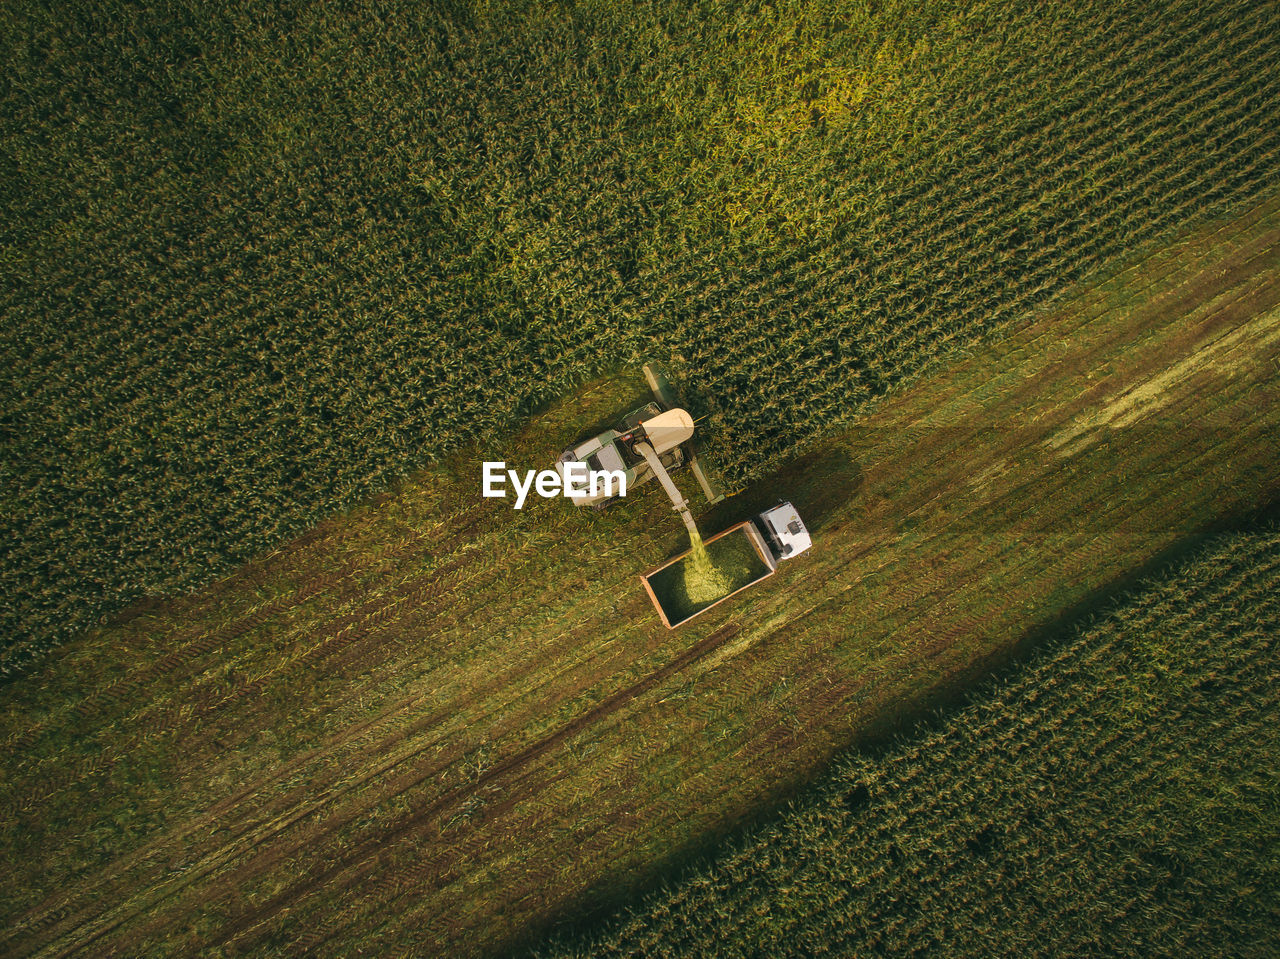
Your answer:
0;194;1280;956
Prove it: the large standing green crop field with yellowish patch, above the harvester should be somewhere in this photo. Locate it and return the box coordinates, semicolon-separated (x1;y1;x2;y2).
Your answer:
0;0;1280;673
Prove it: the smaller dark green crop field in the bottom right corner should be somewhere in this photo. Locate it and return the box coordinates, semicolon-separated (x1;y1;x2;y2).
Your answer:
550;525;1280;959
